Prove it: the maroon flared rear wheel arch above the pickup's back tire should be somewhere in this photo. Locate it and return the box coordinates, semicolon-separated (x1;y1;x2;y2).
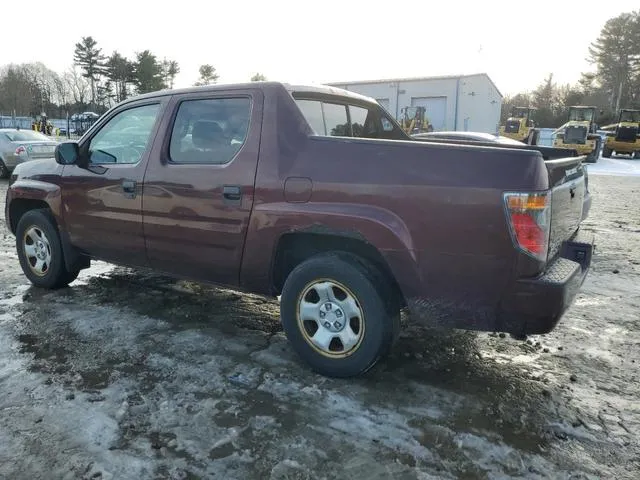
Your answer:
240;202;421;304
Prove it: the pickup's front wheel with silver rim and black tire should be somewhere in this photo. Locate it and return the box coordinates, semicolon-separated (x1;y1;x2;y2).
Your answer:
16;209;80;289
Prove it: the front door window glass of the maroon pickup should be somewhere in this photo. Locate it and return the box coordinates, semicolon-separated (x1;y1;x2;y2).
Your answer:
89;104;160;164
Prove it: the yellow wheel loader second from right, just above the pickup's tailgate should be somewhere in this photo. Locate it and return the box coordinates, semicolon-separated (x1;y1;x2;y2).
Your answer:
553;105;602;163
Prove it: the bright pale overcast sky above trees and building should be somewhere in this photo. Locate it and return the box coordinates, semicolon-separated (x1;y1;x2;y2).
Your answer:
0;0;640;94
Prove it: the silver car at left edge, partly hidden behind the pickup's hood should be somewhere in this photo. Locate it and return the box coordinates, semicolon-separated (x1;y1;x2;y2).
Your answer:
0;128;58;178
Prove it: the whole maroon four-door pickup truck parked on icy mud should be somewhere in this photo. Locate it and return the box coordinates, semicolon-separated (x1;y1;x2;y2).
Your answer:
6;82;593;377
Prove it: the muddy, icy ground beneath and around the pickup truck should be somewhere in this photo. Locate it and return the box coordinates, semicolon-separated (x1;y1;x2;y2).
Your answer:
0;175;640;480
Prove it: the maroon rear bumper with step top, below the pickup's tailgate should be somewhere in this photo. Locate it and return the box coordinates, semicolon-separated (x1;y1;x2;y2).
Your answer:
496;232;593;335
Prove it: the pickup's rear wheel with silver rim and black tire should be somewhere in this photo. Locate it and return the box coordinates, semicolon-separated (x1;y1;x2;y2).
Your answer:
280;253;400;378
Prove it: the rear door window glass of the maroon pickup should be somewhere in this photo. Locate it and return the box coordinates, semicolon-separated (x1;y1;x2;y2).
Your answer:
169;97;251;165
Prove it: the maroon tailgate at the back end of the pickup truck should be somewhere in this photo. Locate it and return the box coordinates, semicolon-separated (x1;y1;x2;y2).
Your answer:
545;157;588;260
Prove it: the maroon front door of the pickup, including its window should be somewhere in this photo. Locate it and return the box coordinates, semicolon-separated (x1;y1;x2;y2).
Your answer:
62;99;166;266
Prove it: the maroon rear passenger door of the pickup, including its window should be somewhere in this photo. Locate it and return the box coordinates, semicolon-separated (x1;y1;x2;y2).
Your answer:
143;89;263;285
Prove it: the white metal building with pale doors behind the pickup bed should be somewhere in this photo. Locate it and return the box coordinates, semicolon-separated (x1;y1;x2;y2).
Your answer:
329;73;502;133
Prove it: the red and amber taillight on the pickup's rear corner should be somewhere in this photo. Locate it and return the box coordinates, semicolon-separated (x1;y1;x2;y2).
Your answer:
504;192;551;260
